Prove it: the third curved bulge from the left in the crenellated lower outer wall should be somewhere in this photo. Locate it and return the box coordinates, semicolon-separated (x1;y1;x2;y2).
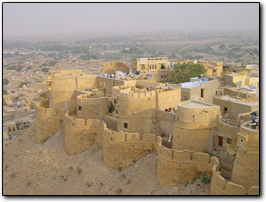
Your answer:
103;128;157;169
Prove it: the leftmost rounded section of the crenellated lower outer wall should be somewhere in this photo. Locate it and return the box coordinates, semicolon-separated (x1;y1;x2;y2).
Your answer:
36;103;66;143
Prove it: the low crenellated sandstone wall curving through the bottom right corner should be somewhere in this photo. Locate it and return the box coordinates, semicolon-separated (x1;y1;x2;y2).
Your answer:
210;165;260;195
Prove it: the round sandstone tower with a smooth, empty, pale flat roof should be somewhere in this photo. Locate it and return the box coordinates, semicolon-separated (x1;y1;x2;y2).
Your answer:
172;100;220;152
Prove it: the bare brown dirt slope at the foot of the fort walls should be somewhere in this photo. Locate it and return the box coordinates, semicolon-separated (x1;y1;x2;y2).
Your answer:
3;125;210;195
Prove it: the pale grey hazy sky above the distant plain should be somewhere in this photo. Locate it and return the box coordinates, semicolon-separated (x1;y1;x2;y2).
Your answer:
3;3;259;37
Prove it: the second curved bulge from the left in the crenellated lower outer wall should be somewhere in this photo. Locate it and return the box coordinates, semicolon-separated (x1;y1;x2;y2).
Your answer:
65;112;104;155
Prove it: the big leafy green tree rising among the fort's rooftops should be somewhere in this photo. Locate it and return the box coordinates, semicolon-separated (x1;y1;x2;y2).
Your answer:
170;62;207;83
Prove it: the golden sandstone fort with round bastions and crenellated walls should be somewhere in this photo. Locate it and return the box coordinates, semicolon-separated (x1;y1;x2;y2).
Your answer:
36;68;259;195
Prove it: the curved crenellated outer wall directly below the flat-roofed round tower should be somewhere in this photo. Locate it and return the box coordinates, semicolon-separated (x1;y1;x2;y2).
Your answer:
157;137;220;186
